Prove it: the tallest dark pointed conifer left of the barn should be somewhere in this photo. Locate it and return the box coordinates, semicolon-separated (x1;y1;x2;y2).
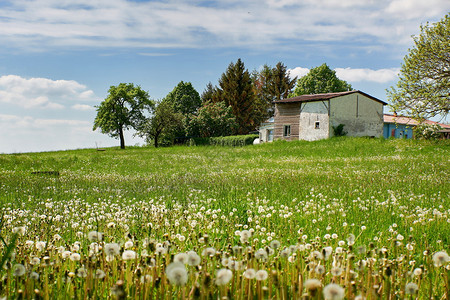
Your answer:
214;59;263;134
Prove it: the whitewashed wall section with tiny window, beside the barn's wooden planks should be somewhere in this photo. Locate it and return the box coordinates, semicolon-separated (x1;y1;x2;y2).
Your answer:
299;100;329;141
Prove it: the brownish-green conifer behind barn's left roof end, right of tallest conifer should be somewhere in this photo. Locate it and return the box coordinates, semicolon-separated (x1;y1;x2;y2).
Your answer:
252;62;297;118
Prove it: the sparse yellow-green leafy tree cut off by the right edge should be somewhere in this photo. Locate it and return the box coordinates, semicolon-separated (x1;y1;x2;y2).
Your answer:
387;14;450;119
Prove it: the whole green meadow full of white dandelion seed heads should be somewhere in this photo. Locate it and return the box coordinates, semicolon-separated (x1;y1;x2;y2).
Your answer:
0;138;450;299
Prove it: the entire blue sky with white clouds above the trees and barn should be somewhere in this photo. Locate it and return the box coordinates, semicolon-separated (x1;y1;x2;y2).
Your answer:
0;0;450;153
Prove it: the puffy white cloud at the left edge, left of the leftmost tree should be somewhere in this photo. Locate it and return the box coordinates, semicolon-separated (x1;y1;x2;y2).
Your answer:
0;75;95;110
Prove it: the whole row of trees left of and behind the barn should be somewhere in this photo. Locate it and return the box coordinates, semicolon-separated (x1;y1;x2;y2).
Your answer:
94;59;351;148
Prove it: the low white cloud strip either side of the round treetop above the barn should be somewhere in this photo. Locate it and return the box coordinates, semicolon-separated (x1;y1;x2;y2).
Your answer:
289;67;400;83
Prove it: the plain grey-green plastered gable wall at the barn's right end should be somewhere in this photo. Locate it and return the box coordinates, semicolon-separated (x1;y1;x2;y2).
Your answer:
330;93;383;137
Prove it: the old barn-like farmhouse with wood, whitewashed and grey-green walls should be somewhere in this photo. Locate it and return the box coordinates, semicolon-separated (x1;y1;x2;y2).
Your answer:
260;91;387;142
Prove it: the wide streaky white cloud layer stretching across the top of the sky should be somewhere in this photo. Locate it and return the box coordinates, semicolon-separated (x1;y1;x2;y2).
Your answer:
0;0;450;51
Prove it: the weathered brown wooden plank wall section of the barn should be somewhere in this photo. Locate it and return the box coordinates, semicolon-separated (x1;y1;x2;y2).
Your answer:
274;103;300;141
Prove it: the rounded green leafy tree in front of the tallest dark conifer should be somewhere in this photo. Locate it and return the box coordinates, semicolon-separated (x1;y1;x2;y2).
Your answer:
186;102;237;137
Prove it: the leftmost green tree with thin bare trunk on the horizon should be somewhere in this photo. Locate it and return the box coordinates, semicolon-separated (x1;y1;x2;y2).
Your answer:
93;83;154;149
